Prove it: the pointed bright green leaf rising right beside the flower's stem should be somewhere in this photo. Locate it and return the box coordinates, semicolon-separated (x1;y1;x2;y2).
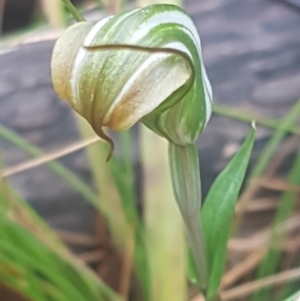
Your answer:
200;123;255;299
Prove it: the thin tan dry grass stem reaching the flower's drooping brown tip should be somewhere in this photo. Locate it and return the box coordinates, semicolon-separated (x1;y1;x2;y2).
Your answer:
0;136;102;178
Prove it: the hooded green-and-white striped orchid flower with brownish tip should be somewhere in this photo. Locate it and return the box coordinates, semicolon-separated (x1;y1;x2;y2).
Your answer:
51;5;212;156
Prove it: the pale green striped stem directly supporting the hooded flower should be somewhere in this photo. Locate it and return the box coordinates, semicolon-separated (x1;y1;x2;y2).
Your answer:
169;143;208;293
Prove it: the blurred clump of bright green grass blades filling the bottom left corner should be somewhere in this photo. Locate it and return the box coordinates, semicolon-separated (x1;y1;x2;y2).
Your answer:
0;178;122;301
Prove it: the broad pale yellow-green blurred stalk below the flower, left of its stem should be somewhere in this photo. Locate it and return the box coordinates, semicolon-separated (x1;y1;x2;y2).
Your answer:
140;126;187;301
